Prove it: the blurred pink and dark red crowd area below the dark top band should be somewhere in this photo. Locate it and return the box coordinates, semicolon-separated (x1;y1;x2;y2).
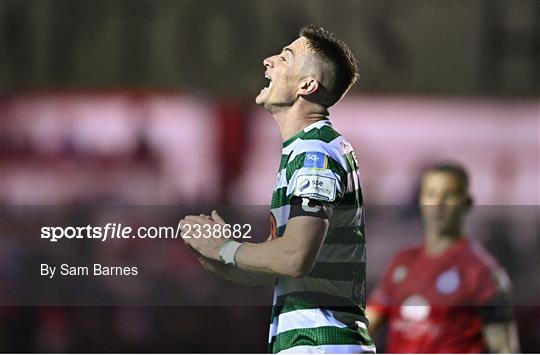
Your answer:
0;92;540;352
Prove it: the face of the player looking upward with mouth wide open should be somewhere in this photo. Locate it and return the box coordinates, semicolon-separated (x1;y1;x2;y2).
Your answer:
255;37;312;112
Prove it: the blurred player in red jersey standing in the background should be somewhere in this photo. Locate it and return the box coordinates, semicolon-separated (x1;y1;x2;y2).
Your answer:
367;164;519;353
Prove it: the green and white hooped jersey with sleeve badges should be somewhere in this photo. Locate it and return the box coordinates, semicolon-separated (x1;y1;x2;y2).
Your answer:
269;120;375;353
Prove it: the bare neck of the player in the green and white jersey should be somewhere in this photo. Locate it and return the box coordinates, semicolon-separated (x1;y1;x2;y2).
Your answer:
272;101;328;142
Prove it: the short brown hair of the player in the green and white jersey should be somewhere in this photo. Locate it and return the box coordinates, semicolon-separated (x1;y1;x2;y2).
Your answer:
299;25;358;106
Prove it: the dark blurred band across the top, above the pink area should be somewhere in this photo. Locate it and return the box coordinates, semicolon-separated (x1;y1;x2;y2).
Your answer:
0;0;540;96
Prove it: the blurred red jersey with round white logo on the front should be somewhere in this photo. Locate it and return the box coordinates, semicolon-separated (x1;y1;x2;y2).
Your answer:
368;239;510;353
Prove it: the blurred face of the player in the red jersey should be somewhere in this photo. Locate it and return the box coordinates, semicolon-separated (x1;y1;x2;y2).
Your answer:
420;172;469;233
